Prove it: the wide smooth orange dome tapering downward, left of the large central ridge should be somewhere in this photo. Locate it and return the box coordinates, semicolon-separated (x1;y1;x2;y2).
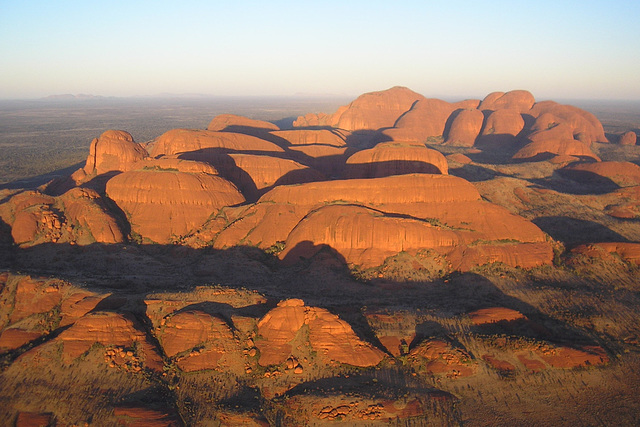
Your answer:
106;171;245;243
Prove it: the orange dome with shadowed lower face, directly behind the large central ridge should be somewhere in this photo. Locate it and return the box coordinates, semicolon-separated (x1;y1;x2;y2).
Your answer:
345;142;449;179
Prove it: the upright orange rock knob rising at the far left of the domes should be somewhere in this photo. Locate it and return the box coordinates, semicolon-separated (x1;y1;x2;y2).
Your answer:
83;130;148;175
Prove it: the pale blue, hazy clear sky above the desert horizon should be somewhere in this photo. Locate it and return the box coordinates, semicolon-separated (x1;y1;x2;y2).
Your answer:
0;0;640;100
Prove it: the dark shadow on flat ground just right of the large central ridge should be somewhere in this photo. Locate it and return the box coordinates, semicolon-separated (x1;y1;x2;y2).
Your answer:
532;216;628;247
